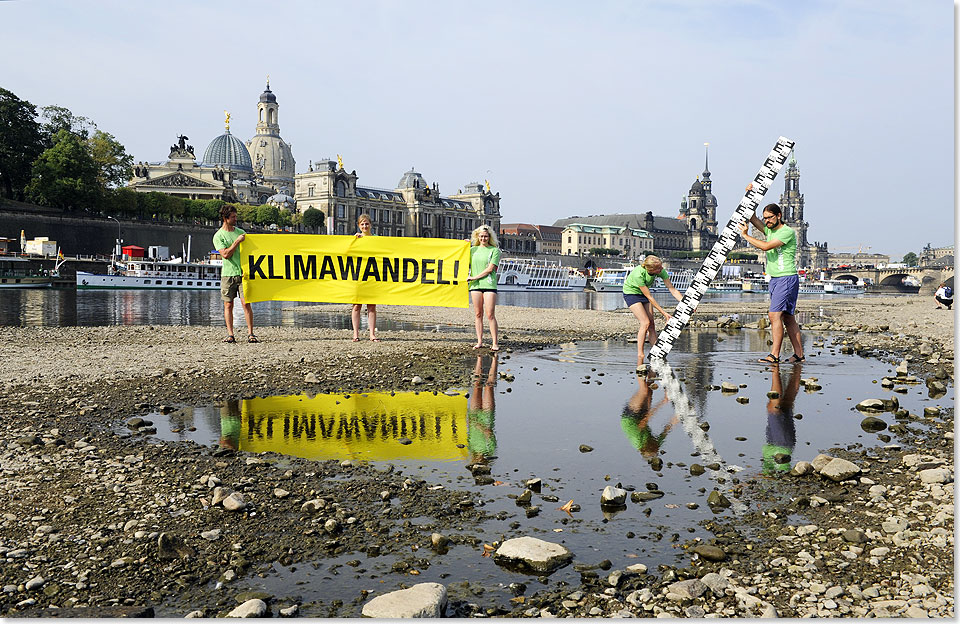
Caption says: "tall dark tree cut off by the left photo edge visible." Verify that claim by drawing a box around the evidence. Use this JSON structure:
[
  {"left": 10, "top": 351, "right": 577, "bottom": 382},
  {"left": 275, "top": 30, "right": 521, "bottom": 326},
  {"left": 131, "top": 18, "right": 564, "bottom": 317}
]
[{"left": 0, "top": 88, "right": 43, "bottom": 199}]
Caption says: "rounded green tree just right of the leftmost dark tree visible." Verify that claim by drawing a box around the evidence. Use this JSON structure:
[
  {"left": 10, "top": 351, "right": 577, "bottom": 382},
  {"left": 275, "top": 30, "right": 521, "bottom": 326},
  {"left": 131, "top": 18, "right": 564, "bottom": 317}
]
[{"left": 27, "top": 130, "right": 102, "bottom": 210}]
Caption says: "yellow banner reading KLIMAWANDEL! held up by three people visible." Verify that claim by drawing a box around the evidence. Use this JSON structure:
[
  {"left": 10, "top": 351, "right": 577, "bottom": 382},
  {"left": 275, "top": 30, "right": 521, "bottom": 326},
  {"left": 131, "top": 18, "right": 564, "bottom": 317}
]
[{"left": 238, "top": 234, "right": 470, "bottom": 308}]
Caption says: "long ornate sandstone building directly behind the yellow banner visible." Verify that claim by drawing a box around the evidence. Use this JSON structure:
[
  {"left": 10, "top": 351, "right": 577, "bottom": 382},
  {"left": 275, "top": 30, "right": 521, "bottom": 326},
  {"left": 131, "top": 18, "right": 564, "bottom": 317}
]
[{"left": 294, "top": 157, "right": 500, "bottom": 239}]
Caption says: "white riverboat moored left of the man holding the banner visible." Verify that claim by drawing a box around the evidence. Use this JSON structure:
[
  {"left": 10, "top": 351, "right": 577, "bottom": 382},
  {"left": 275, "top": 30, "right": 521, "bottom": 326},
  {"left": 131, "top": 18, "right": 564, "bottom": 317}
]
[{"left": 77, "top": 259, "right": 222, "bottom": 290}]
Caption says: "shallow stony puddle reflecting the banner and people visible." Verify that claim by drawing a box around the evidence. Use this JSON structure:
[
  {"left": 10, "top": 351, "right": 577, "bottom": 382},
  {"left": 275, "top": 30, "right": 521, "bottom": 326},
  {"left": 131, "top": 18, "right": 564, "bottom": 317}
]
[{"left": 151, "top": 331, "right": 952, "bottom": 617}]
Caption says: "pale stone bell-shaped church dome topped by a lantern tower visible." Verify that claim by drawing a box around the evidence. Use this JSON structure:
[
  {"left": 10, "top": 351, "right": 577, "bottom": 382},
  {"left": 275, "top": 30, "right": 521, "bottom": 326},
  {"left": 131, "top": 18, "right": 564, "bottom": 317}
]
[{"left": 246, "top": 78, "right": 296, "bottom": 194}]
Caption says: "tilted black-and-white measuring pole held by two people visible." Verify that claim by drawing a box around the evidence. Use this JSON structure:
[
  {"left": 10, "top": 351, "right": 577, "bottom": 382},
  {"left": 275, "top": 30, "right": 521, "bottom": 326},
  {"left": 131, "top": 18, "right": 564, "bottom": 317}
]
[{"left": 650, "top": 137, "right": 793, "bottom": 361}]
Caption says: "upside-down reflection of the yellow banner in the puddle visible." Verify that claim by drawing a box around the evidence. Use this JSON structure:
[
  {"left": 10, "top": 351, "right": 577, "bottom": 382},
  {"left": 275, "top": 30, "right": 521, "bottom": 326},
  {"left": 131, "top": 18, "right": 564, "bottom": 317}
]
[{"left": 220, "top": 392, "right": 467, "bottom": 461}]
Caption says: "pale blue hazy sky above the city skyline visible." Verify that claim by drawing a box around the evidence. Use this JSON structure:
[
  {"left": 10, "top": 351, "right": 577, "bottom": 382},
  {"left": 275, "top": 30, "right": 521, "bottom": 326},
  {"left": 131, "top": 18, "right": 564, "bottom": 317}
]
[{"left": 0, "top": 0, "right": 955, "bottom": 259}]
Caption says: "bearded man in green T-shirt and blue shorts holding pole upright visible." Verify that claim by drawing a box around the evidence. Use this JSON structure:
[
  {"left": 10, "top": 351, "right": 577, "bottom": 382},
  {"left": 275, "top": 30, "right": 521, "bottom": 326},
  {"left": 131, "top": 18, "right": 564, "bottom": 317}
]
[{"left": 740, "top": 183, "right": 804, "bottom": 364}]
